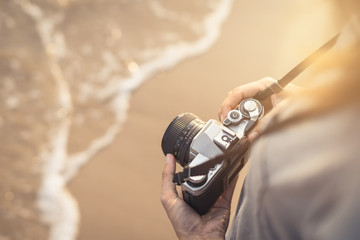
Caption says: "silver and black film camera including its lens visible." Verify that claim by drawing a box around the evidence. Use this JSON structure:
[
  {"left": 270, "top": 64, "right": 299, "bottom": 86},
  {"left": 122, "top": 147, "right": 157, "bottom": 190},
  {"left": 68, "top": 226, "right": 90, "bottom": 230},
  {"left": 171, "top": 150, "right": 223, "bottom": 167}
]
[{"left": 162, "top": 98, "right": 264, "bottom": 215}]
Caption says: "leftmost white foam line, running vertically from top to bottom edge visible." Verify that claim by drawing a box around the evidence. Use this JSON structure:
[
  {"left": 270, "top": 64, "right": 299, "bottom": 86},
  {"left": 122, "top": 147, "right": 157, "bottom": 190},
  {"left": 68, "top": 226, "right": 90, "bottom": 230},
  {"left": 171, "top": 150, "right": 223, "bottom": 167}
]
[{"left": 16, "top": 0, "right": 79, "bottom": 240}]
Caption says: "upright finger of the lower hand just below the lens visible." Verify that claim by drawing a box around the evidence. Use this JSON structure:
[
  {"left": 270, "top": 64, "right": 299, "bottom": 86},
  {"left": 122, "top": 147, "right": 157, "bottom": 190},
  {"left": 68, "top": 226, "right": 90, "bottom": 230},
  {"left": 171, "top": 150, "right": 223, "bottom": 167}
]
[{"left": 161, "top": 154, "right": 178, "bottom": 207}]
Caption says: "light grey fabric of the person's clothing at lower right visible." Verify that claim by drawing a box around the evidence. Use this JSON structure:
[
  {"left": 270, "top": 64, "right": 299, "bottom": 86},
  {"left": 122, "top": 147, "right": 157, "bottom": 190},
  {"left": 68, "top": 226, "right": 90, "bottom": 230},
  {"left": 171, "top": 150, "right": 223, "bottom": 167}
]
[{"left": 227, "top": 107, "right": 360, "bottom": 240}]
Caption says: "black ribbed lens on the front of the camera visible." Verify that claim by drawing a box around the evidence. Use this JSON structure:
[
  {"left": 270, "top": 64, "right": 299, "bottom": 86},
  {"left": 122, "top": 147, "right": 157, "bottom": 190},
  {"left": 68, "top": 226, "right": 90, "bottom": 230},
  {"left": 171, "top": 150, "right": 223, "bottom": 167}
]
[{"left": 161, "top": 113, "right": 205, "bottom": 167}]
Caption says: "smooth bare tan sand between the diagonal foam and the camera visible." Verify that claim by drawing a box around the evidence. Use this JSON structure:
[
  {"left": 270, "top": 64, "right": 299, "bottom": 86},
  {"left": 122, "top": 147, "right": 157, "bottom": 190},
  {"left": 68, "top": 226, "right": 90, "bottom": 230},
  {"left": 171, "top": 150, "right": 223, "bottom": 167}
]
[{"left": 69, "top": 1, "right": 338, "bottom": 240}]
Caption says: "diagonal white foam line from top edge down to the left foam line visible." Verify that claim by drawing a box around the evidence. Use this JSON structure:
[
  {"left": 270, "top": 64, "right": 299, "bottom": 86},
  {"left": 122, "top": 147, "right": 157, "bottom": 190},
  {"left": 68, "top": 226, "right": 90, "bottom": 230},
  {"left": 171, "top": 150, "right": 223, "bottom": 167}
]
[{"left": 64, "top": 0, "right": 233, "bottom": 181}]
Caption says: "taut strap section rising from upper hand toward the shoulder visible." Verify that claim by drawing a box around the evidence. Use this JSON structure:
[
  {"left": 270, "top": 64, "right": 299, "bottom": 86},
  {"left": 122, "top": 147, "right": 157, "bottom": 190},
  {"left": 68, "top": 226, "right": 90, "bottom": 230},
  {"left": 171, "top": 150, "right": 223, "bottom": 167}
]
[{"left": 254, "top": 34, "right": 340, "bottom": 101}]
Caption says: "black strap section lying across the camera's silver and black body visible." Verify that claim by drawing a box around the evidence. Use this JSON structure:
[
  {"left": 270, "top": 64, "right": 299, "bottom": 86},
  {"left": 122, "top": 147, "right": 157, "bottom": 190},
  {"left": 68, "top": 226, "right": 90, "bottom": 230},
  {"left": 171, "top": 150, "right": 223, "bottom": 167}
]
[{"left": 173, "top": 137, "right": 249, "bottom": 185}]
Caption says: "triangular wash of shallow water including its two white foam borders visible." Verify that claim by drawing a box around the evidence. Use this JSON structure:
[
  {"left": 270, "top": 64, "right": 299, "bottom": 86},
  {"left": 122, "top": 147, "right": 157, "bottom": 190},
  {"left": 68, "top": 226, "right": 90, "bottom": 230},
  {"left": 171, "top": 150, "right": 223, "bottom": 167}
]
[{"left": 10, "top": 0, "right": 233, "bottom": 240}]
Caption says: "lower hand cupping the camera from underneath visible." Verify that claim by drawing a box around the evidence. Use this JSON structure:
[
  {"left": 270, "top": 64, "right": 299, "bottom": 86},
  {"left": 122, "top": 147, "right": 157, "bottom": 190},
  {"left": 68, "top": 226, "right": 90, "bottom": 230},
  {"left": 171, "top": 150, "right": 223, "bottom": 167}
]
[{"left": 161, "top": 154, "right": 237, "bottom": 239}]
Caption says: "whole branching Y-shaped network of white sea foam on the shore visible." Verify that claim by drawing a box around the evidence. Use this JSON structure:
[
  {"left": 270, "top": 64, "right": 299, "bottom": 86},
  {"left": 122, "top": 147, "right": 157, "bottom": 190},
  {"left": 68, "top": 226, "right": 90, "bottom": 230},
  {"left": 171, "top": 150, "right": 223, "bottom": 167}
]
[{"left": 17, "top": 0, "right": 233, "bottom": 240}]
